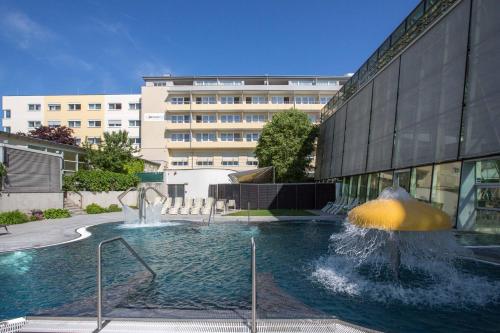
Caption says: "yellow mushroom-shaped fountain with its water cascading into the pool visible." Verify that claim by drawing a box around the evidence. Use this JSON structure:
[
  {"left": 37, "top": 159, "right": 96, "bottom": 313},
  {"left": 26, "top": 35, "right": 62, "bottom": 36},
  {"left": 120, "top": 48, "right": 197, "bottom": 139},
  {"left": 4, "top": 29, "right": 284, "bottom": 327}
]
[{"left": 313, "top": 188, "right": 500, "bottom": 306}]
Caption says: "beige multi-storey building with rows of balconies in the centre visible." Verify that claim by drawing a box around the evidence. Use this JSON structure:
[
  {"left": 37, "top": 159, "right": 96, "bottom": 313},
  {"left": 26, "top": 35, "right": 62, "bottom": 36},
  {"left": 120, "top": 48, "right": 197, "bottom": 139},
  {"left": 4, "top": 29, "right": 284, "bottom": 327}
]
[{"left": 141, "top": 76, "right": 349, "bottom": 171}]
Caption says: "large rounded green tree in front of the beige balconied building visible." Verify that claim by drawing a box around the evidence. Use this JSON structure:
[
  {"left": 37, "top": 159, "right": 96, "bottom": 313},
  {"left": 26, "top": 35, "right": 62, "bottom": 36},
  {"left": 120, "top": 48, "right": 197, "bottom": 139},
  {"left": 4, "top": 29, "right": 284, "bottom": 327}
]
[{"left": 255, "top": 108, "right": 318, "bottom": 182}]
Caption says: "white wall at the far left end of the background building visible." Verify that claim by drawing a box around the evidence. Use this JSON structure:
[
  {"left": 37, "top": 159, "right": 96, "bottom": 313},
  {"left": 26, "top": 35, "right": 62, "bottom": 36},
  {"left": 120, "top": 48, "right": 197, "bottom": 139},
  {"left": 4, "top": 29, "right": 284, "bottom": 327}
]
[{"left": 2, "top": 96, "right": 45, "bottom": 133}]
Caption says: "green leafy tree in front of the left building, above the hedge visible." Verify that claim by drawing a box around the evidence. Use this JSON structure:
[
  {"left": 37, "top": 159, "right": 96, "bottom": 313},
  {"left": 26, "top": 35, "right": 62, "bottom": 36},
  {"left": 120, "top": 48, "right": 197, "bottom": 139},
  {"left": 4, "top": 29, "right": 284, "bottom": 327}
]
[{"left": 84, "top": 131, "right": 141, "bottom": 173}]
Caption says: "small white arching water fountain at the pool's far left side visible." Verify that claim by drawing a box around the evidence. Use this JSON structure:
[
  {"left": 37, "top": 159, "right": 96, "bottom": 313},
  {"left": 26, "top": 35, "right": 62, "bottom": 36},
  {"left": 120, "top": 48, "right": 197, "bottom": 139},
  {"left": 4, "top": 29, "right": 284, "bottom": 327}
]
[{"left": 118, "top": 186, "right": 167, "bottom": 226}]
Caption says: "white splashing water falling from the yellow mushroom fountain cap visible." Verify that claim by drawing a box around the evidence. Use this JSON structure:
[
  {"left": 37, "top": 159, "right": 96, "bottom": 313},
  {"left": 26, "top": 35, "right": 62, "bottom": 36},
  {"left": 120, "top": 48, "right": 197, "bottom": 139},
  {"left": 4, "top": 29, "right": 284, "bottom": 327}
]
[{"left": 313, "top": 188, "right": 500, "bottom": 307}]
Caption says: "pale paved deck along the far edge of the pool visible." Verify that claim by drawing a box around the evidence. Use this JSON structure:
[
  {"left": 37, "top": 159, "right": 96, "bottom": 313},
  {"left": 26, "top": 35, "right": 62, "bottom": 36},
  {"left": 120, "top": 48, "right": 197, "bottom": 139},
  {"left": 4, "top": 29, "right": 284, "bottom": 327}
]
[{"left": 0, "top": 212, "right": 340, "bottom": 252}]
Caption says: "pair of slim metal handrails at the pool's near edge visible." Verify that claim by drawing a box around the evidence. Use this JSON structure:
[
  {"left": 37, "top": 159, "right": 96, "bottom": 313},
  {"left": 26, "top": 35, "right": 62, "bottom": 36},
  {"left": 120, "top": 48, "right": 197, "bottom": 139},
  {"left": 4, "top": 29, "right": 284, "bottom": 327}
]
[{"left": 97, "top": 237, "right": 257, "bottom": 333}]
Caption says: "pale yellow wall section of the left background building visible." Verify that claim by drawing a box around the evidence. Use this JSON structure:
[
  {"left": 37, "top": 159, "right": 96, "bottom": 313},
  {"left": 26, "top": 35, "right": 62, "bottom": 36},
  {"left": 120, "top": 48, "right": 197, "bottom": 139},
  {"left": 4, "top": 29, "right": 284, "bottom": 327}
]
[{"left": 42, "top": 95, "right": 106, "bottom": 142}]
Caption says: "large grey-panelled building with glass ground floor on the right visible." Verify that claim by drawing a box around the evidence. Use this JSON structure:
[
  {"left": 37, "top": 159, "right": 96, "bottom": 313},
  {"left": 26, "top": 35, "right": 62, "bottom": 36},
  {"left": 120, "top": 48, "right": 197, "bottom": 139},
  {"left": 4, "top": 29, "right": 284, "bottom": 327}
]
[{"left": 315, "top": 0, "right": 500, "bottom": 232}]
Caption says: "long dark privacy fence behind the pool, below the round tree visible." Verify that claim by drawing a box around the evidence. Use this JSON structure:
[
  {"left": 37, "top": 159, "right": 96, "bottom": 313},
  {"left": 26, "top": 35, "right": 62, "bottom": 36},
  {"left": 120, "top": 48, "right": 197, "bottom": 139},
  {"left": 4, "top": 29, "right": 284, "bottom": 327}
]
[{"left": 208, "top": 183, "right": 335, "bottom": 209}]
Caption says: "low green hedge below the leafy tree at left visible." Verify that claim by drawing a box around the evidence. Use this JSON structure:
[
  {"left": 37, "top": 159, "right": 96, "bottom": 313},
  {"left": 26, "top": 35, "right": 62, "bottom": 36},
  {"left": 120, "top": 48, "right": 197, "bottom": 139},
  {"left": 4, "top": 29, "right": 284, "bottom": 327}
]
[{"left": 63, "top": 170, "right": 139, "bottom": 192}]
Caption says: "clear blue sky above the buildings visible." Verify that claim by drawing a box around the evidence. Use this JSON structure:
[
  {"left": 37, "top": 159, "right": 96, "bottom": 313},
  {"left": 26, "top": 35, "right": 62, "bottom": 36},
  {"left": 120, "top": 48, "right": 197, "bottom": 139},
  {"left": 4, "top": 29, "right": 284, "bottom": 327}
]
[{"left": 0, "top": 0, "right": 418, "bottom": 95}]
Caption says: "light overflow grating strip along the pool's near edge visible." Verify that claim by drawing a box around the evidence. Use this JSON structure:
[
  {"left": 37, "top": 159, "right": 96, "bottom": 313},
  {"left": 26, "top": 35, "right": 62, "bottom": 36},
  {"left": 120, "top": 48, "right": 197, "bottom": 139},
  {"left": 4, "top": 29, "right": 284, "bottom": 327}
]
[{"left": 17, "top": 318, "right": 376, "bottom": 333}]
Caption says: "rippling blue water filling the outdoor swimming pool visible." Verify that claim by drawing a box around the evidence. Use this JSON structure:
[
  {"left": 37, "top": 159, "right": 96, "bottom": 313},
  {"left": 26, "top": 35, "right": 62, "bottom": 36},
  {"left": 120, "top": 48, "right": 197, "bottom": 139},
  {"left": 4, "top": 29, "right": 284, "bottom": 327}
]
[{"left": 0, "top": 222, "right": 500, "bottom": 332}]
